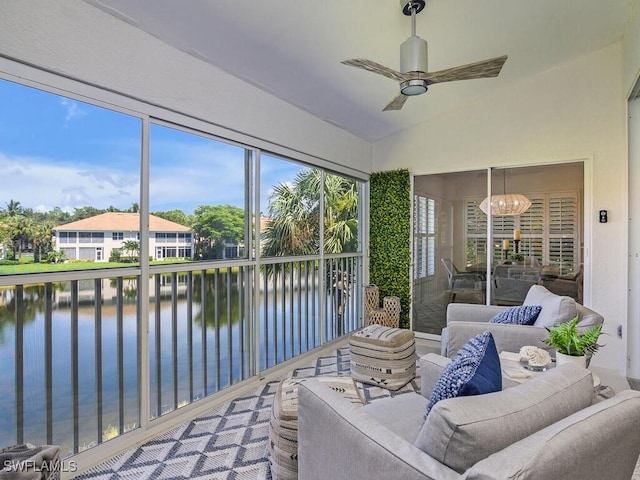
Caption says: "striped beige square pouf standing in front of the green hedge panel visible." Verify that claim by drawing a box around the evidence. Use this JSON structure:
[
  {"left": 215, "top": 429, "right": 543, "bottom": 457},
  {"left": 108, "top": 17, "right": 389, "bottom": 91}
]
[{"left": 349, "top": 325, "right": 416, "bottom": 390}]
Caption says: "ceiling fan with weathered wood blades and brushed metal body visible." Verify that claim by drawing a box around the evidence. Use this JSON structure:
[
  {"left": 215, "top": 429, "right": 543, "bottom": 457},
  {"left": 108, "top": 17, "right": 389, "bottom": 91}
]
[{"left": 341, "top": 0, "right": 507, "bottom": 111}]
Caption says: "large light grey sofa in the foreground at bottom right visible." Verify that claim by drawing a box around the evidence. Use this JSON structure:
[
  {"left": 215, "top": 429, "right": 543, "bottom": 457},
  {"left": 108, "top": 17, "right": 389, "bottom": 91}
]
[{"left": 298, "top": 354, "right": 640, "bottom": 480}]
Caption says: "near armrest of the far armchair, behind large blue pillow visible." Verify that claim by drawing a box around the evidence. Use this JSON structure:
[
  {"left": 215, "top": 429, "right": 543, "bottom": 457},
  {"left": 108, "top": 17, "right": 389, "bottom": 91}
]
[{"left": 441, "top": 322, "right": 553, "bottom": 358}]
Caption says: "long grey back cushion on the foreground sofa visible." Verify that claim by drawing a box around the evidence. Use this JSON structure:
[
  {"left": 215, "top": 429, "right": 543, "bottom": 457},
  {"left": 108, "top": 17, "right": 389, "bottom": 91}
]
[{"left": 415, "top": 365, "right": 593, "bottom": 473}]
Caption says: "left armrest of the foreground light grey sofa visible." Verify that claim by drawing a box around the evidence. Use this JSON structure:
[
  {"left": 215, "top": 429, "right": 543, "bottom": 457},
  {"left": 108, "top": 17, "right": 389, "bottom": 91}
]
[{"left": 298, "top": 381, "right": 459, "bottom": 480}]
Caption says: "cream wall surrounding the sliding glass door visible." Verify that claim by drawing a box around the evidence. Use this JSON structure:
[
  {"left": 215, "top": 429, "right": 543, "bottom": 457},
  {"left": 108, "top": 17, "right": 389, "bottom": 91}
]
[{"left": 373, "top": 43, "right": 627, "bottom": 371}]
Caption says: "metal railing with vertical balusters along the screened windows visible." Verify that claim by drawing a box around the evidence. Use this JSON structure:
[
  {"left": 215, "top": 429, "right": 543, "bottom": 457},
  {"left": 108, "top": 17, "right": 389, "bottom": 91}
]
[{"left": 0, "top": 254, "right": 362, "bottom": 456}]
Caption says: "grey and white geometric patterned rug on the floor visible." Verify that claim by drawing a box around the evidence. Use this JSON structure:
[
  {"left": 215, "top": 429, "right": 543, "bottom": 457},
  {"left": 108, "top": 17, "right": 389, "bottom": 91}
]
[{"left": 75, "top": 346, "right": 420, "bottom": 480}]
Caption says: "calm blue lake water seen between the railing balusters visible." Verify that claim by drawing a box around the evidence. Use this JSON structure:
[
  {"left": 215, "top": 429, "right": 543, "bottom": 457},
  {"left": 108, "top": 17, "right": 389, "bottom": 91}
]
[{"left": 0, "top": 273, "right": 331, "bottom": 456}]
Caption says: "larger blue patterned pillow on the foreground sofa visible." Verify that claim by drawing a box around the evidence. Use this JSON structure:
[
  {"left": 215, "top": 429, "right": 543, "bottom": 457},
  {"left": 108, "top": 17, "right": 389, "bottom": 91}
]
[{"left": 424, "top": 332, "right": 502, "bottom": 418}]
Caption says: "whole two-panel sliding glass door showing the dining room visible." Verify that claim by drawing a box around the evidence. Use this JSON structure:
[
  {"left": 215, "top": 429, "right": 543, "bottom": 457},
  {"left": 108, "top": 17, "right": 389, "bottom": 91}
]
[{"left": 412, "top": 162, "right": 584, "bottom": 335}]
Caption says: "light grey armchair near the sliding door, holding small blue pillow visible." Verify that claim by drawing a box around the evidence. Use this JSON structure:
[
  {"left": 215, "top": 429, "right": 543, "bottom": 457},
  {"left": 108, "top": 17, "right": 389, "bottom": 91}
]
[{"left": 440, "top": 285, "right": 604, "bottom": 357}]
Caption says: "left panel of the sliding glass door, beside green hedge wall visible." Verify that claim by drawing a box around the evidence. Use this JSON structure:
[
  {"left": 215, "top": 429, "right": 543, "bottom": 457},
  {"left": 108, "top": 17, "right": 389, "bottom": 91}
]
[{"left": 412, "top": 170, "right": 487, "bottom": 335}]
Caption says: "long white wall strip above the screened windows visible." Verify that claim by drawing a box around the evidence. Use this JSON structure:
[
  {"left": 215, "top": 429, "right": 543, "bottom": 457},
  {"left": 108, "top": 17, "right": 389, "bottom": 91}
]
[{"left": 0, "top": 0, "right": 371, "bottom": 173}]
